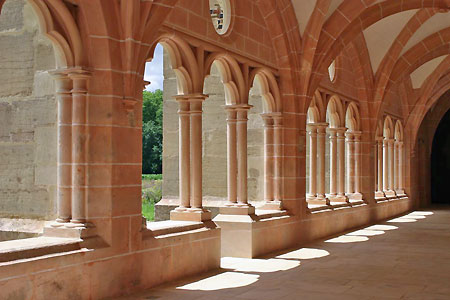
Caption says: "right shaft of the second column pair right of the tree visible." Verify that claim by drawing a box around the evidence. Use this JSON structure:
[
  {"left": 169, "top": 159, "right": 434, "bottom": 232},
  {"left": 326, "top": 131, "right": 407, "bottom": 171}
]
[{"left": 236, "top": 105, "right": 251, "bottom": 207}]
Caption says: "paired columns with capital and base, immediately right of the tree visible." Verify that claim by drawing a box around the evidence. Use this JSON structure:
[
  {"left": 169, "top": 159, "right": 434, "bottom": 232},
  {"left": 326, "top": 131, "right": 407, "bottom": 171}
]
[{"left": 170, "top": 94, "right": 211, "bottom": 221}]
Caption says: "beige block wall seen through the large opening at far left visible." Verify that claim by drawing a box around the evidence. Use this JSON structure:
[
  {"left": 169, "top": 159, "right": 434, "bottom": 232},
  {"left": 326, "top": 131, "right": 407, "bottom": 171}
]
[{"left": 0, "top": 0, "right": 57, "bottom": 219}]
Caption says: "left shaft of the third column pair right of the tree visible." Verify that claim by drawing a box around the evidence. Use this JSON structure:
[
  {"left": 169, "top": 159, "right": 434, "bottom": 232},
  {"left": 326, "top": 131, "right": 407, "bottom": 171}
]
[{"left": 261, "top": 114, "right": 274, "bottom": 202}]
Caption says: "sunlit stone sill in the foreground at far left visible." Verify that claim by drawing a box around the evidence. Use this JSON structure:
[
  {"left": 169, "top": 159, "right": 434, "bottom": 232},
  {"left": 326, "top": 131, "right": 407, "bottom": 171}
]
[{"left": 0, "top": 237, "right": 83, "bottom": 266}]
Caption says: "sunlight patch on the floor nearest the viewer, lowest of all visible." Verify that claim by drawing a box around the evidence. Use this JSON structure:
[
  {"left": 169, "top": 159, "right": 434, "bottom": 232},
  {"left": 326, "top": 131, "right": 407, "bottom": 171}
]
[{"left": 177, "top": 272, "right": 259, "bottom": 291}]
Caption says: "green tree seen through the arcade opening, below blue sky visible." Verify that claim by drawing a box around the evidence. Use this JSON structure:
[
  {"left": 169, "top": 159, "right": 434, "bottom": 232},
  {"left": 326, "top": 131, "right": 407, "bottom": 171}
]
[{"left": 142, "top": 90, "right": 163, "bottom": 174}]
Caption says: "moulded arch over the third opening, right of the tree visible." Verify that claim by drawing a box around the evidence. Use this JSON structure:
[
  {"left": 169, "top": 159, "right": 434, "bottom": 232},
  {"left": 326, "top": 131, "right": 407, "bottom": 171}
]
[{"left": 250, "top": 68, "right": 281, "bottom": 113}]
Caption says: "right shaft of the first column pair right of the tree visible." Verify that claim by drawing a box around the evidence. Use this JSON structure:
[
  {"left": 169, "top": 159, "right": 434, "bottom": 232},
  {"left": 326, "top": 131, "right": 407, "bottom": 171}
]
[{"left": 189, "top": 95, "right": 205, "bottom": 211}]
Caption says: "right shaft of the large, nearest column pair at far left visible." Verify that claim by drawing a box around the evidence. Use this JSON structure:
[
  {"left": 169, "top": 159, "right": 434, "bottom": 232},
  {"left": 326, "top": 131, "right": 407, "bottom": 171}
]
[{"left": 69, "top": 70, "right": 90, "bottom": 226}]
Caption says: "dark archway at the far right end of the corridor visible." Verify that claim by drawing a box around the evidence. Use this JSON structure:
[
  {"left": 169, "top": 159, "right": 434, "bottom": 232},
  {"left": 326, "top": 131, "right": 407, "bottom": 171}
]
[{"left": 431, "top": 110, "right": 450, "bottom": 204}]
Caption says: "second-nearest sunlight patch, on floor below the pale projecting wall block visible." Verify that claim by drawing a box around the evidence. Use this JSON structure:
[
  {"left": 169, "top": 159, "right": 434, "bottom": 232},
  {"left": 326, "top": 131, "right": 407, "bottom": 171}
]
[{"left": 221, "top": 257, "right": 300, "bottom": 273}]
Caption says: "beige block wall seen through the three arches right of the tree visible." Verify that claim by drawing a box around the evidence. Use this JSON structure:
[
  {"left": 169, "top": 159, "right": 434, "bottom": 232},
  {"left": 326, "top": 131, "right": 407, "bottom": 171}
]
[{"left": 162, "top": 51, "right": 264, "bottom": 212}]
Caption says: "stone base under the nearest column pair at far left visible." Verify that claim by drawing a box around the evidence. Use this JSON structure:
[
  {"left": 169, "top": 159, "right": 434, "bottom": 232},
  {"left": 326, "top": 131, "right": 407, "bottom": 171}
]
[{"left": 43, "top": 221, "right": 97, "bottom": 239}]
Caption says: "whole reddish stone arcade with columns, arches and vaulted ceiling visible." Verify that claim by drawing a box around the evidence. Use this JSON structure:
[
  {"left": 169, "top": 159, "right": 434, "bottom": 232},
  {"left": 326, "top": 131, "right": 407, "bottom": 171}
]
[{"left": 0, "top": 0, "right": 450, "bottom": 299}]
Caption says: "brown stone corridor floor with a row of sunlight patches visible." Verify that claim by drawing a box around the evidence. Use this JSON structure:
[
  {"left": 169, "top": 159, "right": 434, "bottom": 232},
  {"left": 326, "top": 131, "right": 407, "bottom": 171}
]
[{"left": 114, "top": 207, "right": 450, "bottom": 300}]
